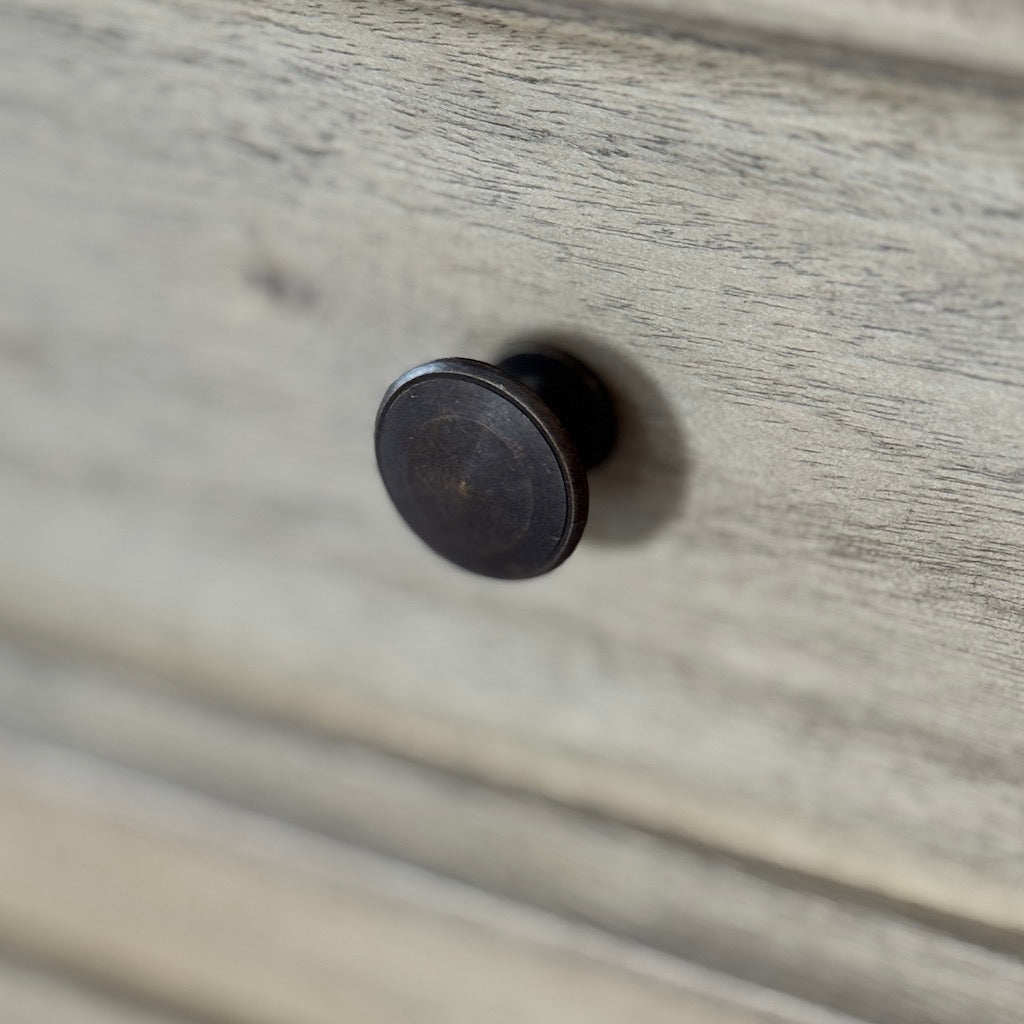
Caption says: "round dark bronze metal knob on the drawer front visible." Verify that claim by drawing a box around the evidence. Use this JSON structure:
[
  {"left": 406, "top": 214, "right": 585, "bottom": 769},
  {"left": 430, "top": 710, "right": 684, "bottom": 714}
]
[{"left": 376, "top": 349, "right": 615, "bottom": 580}]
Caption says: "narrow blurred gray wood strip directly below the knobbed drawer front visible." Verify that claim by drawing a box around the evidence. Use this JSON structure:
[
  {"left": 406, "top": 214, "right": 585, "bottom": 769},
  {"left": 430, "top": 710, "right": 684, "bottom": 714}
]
[{"left": 0, "top": 641, "right": 1024, "bottom": 1024}]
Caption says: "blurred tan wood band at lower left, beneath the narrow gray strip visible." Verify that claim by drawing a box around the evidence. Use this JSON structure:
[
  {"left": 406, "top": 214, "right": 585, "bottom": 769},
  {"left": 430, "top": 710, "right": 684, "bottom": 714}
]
[{"left": 0, "top": 737, "right": 851, "bottom": 1024}]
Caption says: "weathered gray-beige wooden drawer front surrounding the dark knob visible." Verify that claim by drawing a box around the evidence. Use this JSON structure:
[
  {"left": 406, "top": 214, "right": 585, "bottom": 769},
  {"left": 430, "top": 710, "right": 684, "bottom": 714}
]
[{"left": 0, "top": 0, "right": 1024, "bottom": 991}]
